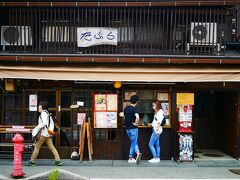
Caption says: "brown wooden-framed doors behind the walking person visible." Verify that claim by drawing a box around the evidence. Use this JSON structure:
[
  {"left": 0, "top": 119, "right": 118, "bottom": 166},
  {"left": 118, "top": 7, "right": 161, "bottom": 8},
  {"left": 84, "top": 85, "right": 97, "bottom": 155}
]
[{"left": 30, "top": 90, "right": 73, "bottom": 158}]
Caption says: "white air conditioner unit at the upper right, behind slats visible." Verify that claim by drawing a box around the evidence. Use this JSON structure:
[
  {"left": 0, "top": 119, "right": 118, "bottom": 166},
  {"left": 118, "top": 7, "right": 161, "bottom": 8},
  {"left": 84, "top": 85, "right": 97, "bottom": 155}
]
[{"left": 190, "top": 22, "right": 217, "bottom": 46}]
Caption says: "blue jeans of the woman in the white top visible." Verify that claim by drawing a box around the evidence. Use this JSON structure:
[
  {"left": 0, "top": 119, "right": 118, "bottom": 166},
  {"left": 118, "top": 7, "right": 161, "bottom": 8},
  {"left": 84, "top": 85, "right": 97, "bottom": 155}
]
[{"left": 149, "top": 130, "right": 160, "bottom": 158}]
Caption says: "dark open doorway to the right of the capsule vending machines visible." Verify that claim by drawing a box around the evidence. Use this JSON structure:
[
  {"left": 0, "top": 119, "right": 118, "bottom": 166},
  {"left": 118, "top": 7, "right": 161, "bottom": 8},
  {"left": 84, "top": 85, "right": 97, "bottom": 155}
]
[{"left": 194, "top": 91, "right": 237, "bottom": 160}]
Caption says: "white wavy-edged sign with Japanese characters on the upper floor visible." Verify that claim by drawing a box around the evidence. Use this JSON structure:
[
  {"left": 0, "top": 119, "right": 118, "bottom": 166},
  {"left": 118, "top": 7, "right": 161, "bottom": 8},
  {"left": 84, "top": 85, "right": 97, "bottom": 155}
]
[{"left": 77, "top": 27, "right": 118, "bottom": 47}]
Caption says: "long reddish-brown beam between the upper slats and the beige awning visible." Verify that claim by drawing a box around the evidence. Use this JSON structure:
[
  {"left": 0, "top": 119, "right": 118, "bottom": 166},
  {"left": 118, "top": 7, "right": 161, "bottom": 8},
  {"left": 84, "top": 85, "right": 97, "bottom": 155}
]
[{"left": 0, "top": 55, "right": 240, "bottom": 65}]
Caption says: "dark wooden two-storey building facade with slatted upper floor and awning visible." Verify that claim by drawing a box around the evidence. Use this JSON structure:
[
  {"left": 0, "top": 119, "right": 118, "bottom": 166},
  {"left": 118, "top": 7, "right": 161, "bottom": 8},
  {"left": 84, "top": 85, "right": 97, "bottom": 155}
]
[{"left": 0, "top": 0, "right": 240, "bottom": 159}]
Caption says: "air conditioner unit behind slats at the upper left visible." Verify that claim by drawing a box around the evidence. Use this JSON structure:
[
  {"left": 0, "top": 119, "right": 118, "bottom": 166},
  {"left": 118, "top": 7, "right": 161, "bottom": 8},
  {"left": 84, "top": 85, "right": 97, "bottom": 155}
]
[{"left": 1, "top": 26, "right": 32, "bottom": 46}]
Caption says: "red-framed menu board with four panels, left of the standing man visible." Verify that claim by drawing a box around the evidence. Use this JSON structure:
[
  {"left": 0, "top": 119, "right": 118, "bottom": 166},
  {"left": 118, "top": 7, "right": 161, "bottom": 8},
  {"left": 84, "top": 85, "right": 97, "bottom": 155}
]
[{"left": 94, "top": 94, "right": 118, "bottom": 128}]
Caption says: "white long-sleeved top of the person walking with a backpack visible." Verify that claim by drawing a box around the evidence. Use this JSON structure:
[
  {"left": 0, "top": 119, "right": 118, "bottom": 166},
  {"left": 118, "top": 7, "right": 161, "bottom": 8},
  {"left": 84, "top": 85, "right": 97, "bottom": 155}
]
[{"left": 36, "top": 111, "right": 51, "bottom": 137}]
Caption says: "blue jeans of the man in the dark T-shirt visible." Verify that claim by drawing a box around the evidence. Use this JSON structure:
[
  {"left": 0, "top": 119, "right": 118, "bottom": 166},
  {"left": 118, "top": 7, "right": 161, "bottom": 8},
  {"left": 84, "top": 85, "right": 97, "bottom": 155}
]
[{"left": 126, "top": 128, "right": 139, "bottom": 158}]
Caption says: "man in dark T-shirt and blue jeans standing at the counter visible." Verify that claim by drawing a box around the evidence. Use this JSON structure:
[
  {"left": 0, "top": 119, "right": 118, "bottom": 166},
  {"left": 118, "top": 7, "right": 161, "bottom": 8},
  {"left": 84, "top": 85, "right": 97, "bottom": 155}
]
[{"left": 124, "top": 95, "right": 141, "bottom": 164}]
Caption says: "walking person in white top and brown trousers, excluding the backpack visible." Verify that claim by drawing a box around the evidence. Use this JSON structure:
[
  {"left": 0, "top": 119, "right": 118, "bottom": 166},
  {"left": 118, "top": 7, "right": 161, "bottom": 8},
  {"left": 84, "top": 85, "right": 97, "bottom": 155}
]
[{"left": 25, "top": 101, "right": 63, "bottom": 166}]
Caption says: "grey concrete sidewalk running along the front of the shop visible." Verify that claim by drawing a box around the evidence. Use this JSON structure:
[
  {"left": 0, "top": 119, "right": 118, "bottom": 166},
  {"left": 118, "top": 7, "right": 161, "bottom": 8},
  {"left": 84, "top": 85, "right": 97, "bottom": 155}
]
[{"left": 0, "top": 159, "right": 240, "bottom": 179}]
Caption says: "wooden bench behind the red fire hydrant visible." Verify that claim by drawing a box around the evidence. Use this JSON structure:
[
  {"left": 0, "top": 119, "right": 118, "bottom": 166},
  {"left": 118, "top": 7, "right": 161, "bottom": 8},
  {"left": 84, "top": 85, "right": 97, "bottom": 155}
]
[{"left": 0, "top": 125, "right": 34, "bottom": 158}]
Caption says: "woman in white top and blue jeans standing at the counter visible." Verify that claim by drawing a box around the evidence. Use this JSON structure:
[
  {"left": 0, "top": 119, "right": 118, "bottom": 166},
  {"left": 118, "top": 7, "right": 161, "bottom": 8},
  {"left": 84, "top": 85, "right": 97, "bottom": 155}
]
[{"left": 148, "top": 100, "right": 164, "bottom": 163}]
